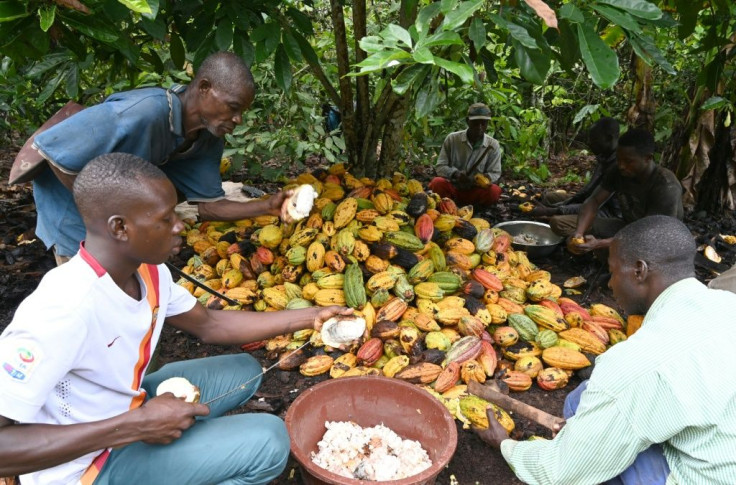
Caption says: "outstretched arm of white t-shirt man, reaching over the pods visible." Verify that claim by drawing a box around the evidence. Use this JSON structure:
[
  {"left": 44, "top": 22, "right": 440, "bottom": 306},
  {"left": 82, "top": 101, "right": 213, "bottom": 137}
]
[{"left": 166, "top": 304, "right": 353, "bottom": 345}]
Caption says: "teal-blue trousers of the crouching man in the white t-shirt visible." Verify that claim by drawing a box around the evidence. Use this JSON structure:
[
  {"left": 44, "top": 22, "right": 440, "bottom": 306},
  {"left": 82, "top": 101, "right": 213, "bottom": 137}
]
[{"left": 95, "top": 354, "right": 289, "bottom": 485}]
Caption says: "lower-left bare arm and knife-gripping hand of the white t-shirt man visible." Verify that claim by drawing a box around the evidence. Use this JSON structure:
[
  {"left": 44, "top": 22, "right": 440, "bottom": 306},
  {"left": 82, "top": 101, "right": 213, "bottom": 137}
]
[{"left": 0, "top": 394, "right": 209, "bottom": 476}]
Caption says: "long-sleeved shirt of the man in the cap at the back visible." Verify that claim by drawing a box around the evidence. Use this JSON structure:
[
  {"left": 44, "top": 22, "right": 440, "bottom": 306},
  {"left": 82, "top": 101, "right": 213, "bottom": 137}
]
[{"left": 437, "top": 130, "right": 503, "bottom": 182}]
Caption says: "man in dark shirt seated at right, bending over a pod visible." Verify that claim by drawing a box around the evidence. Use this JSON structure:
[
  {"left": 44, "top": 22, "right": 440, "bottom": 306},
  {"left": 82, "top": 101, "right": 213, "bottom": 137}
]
[{"left": 568, "top": 129, "right": 683, "bottom": 254}]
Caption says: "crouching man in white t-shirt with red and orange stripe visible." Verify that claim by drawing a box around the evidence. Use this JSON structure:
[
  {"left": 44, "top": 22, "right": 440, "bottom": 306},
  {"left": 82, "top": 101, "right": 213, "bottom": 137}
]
[{"left": 0, "top": 153, "right": 351, "bottom": 485}]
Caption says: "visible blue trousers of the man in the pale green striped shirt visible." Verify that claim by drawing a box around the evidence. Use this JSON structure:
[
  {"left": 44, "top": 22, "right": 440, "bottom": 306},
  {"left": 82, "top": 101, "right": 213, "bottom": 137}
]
[{"left": 562, "top": 380, "right": 670, "bottom": 485}]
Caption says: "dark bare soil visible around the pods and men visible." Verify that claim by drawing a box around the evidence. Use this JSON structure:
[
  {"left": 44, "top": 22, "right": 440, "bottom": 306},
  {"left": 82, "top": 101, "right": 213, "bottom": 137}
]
[{"left": 0, "top": 149, "right": 736, "bottom": 485}]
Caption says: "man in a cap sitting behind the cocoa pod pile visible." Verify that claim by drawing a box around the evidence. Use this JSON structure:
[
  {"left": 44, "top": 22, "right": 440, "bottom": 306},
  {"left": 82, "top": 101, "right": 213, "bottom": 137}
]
[{"left": 429, "top": 103, "right": 503, "bottom": 205}]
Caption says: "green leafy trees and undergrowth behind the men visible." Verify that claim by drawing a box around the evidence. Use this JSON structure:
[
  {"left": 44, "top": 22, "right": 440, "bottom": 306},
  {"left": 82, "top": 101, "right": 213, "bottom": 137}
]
[{"left": 0, "top": 0, "right": 736, "bottom": 215}]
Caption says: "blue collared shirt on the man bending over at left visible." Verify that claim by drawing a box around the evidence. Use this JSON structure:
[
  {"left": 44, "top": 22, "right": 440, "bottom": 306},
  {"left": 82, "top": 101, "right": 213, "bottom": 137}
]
[{"left": 33, "top": 85, "right": 225, "bottom": 256}]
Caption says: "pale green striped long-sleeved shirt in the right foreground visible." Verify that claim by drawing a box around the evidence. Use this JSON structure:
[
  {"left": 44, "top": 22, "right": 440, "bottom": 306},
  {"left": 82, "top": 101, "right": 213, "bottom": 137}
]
[{"left": 501, "top": 278, "right": 736, "bottom": 485}]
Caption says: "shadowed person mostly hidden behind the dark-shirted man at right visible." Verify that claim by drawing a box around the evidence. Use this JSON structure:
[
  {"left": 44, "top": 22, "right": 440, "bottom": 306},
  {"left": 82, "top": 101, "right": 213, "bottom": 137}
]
[{"left": 530, "top": 118, "right": 621, "bottom": 231}]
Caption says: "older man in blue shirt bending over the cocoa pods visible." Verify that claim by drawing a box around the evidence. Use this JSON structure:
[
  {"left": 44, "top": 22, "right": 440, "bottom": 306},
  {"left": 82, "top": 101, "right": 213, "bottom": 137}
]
[{"left": 33, "top": 52, "right": 287, "bottom": 263}]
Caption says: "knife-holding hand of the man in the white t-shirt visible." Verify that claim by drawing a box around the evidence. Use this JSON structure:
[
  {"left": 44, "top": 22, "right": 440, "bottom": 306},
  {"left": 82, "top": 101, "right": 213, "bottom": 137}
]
[{"left": 134, "top": 392, "right": 210, "bottom": 445}]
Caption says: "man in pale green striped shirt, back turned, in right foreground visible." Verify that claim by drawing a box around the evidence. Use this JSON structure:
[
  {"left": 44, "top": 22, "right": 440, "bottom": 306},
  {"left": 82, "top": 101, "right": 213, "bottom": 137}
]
[{"left": 478, "top": 215, "right": 736, "bottom": 485}]
